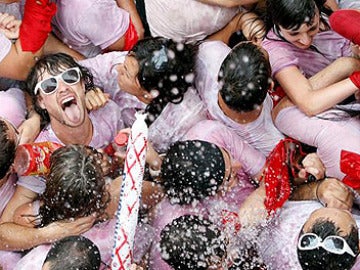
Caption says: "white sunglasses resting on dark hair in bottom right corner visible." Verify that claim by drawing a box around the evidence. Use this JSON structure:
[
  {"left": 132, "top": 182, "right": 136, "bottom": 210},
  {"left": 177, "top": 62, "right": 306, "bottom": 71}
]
[{"left": 298, "top": 233, "right": 356, "bottom": 257}]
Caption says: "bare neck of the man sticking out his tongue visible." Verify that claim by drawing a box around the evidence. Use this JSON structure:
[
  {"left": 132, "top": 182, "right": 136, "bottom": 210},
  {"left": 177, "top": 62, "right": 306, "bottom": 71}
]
[{"left": 51, "top": 116, "right": 93, "bottom": 145}]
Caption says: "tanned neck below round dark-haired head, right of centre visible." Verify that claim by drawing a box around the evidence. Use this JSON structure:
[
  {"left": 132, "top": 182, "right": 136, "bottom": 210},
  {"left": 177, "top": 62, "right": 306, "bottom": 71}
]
[{"left": 218, "top": 94, "right": 262, "bottom": 124}]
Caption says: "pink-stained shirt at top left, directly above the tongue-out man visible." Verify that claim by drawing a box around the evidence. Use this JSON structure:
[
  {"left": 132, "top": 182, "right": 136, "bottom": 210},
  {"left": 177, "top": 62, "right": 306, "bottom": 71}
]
[{"left": 52, "top": 0, "right": 130, "bottom": 57}]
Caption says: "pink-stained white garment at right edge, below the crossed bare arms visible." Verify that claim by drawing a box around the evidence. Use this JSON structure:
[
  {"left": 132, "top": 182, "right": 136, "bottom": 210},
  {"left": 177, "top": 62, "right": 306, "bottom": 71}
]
[{"left": 275, "top": 106, "right": 360, "bottom": 179}]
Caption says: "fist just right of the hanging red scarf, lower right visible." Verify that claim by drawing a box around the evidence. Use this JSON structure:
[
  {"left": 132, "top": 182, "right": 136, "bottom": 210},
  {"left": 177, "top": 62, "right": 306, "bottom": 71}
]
[{"left": 299, "top": 153, "right": 325, "bottom": 180}]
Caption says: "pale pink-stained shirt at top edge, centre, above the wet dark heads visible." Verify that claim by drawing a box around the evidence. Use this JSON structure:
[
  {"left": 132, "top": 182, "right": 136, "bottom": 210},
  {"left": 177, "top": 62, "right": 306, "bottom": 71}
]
[{"left": 144, "top": 0, "right": 239, "bottom": 42}]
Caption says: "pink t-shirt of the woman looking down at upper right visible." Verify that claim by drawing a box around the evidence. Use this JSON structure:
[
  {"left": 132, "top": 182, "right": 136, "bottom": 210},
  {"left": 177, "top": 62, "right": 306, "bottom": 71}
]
[{"left": 262, "top": 28, "right": 352, "bottom": 78}]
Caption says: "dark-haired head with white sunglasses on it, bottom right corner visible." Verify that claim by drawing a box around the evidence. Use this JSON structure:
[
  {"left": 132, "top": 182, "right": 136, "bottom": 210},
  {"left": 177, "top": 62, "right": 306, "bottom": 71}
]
[{"left": 297, "top": 209, "right": 359, "bottom": 270}]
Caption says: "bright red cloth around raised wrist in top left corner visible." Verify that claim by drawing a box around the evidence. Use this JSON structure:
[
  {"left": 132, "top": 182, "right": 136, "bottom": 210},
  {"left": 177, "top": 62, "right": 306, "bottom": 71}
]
[{"left": 20, "top": 0, "right": 56, "bottom": 53}]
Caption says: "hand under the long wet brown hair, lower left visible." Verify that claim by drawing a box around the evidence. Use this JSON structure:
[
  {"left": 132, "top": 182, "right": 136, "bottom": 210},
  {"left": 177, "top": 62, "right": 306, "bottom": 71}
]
[{"left": 42, "top": 215, "right": 96, "bottom": 242}]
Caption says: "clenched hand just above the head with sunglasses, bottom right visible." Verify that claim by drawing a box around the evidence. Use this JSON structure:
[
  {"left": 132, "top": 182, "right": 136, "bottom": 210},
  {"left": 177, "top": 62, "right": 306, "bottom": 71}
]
[{"left": 316, "top": 178, "right": 354, "bottom": 210}]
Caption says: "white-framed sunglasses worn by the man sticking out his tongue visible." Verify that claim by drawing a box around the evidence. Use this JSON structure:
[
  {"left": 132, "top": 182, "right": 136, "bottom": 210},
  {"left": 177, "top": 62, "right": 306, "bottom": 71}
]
[{"left": 34, "top": 67, "right": 81, "bottom": 95}]
